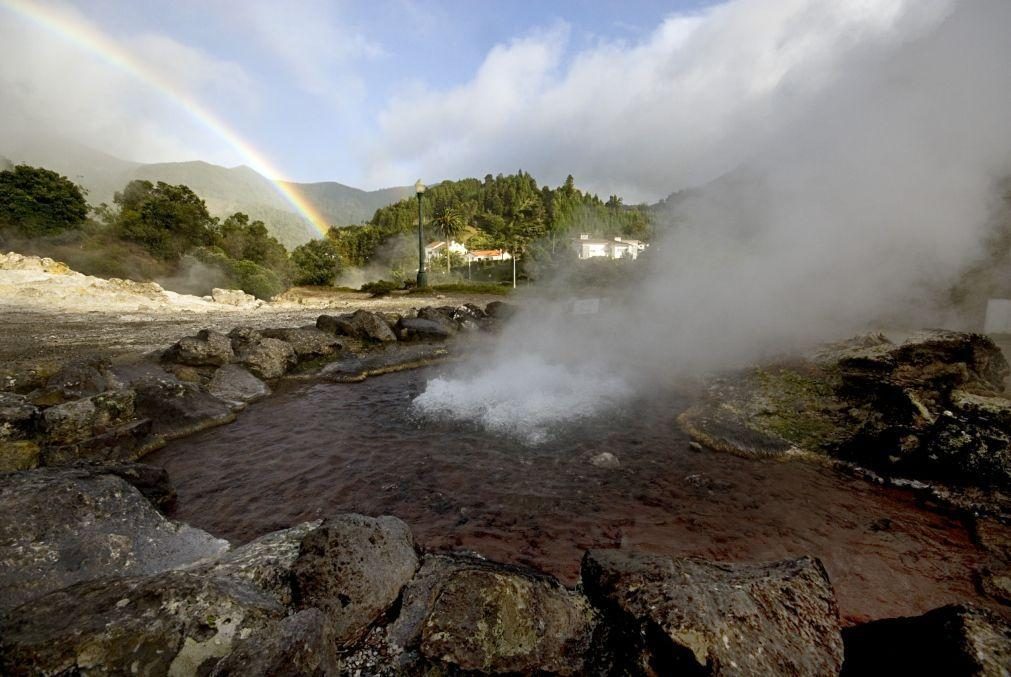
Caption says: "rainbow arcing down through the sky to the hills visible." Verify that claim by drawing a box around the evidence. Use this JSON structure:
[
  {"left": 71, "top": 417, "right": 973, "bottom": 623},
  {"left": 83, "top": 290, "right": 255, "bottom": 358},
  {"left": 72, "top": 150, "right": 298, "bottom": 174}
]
[{"left": 0, "top": 0, "right": 328, "bottom": 235}]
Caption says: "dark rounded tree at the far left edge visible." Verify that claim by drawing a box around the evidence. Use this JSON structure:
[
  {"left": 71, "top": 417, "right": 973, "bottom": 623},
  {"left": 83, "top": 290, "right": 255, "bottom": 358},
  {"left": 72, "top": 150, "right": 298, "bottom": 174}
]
[{"left": 0, "top": 165, "right": 88, "bottom": 237}]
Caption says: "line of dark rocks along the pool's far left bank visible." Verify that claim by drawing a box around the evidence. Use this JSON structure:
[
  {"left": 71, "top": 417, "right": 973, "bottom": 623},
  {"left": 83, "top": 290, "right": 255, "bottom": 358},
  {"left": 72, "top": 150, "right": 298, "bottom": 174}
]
[{"left": 0, "top": 305, "right": 517, "bottom": 473}]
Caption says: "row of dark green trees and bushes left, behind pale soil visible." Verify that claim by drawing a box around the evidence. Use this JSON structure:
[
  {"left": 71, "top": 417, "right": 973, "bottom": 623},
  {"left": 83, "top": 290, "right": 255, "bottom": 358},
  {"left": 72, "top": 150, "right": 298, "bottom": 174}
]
[{"left": 0, "top": 165, "right": 341, "bottom": 298}]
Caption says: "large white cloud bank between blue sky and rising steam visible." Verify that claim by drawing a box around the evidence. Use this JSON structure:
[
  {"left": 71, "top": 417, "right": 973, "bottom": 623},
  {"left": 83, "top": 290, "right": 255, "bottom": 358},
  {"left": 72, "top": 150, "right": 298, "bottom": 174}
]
[{"left": 364, "top": 0, "right": 951, "bottom": 199}]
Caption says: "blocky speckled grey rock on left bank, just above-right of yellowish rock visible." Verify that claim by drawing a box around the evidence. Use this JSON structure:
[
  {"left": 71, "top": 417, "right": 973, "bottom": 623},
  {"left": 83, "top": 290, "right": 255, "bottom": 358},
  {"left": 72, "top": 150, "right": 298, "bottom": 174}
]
[{"left": 41, "top": 390, "right": 134, "bottom": 446}]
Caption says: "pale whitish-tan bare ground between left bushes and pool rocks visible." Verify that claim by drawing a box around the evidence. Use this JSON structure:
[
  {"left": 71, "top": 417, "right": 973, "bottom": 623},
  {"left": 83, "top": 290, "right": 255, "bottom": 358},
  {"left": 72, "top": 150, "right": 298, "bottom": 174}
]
[{"left": 0, "top": 262, "right": 503, "bottom": 372}]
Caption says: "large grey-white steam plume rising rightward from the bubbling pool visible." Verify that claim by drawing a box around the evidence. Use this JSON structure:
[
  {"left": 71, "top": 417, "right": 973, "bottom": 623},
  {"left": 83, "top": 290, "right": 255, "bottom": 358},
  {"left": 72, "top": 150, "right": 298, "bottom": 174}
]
[{"left": 416, "top": 0, "right": 1011, "bottom": 440}]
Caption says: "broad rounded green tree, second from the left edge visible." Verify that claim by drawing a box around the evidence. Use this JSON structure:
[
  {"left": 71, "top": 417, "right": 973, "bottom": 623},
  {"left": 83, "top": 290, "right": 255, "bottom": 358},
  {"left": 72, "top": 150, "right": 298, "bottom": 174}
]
[{"left": 111, "top": 181, "right": 214, "bottom": 261}]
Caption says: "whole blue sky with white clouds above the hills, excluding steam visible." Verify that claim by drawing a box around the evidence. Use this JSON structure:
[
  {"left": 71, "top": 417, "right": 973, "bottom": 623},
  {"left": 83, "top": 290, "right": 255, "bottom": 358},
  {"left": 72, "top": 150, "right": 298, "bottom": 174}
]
[{"left": 0, "top": 0, "right": 951, "bottom": 199}]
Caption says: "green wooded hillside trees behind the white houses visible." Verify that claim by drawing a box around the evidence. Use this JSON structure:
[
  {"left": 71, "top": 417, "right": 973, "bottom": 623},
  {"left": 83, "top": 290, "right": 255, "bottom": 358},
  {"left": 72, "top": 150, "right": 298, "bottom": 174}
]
[{"left": 329, "top": 171, "right": 650, "bottom": 267}]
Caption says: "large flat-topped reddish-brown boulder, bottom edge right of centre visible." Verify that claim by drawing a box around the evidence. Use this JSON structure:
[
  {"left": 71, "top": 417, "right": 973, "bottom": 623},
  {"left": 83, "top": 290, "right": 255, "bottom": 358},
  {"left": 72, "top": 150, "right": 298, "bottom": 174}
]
[{"left": 582, "top": 550, "right": 843, "bottom": 675}]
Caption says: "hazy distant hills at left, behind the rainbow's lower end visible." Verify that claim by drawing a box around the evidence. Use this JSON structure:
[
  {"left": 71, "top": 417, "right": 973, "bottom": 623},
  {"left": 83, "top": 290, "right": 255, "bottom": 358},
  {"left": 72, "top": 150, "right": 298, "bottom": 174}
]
[{"left": 0, "top": 136, "right": 412, "bottom": 250}]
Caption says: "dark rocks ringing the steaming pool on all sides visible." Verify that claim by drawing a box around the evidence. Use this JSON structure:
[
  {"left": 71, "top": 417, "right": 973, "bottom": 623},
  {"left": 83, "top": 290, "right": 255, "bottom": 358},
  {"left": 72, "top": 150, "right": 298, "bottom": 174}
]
[{"left": 0, "top": 317, "right": 1011, "bottom": 675}]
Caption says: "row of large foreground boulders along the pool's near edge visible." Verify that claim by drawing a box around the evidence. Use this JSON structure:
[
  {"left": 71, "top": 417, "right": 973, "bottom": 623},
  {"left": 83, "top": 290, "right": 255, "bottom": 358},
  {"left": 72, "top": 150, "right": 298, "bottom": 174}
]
[{"left": 0, "top": 467, "right": 1011, "bottom": 675}]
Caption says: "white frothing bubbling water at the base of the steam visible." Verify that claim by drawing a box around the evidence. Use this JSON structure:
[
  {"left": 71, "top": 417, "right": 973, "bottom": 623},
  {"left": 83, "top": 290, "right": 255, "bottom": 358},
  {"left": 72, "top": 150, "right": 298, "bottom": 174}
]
[{"left": 413, "top": 355, "right": 633, "bottom": 445}]
